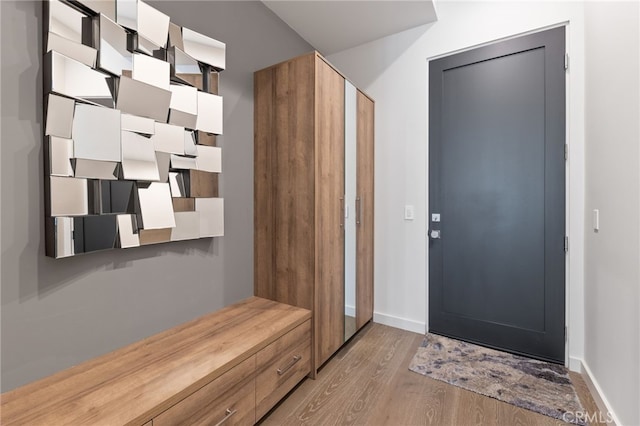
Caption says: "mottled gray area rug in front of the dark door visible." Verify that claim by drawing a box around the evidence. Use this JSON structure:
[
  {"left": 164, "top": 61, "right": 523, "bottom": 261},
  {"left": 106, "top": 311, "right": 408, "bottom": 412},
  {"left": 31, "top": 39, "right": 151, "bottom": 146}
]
[{"left": 409, "top": 333, "right": 584, "bottom": 424}]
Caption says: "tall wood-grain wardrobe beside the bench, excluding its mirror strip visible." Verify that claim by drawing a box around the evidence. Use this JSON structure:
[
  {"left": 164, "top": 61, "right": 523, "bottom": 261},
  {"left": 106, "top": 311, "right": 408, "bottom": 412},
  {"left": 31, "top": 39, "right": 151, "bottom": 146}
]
[{"left": 254, "top": 52, "right": 373, "bottom": 376}]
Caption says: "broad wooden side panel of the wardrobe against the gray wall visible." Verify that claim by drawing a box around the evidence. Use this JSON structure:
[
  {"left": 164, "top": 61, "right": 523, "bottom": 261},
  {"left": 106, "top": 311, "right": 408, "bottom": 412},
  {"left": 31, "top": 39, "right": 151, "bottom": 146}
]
[{"left": 254, "top": 55, "right": 315, "bottom": 309}]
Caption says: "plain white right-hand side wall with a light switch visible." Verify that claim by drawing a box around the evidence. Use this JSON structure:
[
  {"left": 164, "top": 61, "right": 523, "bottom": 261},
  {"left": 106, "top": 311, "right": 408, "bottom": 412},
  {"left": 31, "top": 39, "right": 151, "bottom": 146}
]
[{"left": 584, "top": 2, "right": 640, "bottom": 425}]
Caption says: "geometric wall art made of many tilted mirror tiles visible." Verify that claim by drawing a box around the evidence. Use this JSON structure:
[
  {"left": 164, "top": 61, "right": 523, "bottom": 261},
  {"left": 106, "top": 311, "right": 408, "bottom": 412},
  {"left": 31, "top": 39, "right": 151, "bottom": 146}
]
[{"left": 43, "top": 0, "right": 225, "bottom": 258}]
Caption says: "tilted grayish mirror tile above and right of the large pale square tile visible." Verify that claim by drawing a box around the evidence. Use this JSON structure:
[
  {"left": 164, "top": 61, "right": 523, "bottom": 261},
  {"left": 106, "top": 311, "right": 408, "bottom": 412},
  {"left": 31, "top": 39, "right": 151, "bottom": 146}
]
[{"left": 116, "top": 76, "right": 171, "bottom": 123}]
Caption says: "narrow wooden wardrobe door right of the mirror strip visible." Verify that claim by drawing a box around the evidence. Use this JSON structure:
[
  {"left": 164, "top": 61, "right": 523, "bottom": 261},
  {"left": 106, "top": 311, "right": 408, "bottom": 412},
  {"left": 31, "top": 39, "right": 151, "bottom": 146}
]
[{"left": 356, "top": 91, "right": 375, "bottom": 329}]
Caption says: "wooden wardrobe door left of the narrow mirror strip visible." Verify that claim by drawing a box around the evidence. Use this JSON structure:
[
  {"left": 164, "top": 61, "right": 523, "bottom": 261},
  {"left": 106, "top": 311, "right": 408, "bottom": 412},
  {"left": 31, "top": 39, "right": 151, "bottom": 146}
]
[{"left": 313, "top": 57, "right": 345, "bottom": 368}]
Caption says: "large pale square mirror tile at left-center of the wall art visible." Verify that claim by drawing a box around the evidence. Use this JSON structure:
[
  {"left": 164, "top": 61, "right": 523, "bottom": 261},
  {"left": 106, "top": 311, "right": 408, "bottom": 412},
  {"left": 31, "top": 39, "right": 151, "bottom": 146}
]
[{"left": 72, "top": 104, "right": 122, "bottom": 161}]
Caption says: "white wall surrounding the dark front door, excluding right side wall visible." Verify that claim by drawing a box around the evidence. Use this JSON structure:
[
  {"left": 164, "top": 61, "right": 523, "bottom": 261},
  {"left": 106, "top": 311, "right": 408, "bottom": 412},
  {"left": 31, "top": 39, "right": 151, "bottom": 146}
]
[{"left": 329, "top": 2, "right": 584, "bottom": 369}]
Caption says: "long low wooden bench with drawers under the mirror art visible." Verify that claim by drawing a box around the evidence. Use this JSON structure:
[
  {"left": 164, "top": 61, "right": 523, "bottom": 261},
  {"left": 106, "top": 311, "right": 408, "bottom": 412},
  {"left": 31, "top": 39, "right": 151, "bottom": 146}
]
[{"left": 0, "top": 297, "right": 311, "bottom": 426}]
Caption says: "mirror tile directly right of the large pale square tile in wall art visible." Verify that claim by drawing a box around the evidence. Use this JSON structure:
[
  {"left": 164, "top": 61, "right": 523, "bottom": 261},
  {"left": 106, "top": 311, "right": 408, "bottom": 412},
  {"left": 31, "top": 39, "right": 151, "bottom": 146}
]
[{"left": 122, "top": 132, "right": 160, "bottom": 181}]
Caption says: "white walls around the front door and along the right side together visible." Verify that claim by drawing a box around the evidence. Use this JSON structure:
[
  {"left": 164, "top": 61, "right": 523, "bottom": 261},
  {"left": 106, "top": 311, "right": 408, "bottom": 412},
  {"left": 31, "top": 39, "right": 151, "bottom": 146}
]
[{"left": 329, "top": 1, "right": 640, "bottom": 425}]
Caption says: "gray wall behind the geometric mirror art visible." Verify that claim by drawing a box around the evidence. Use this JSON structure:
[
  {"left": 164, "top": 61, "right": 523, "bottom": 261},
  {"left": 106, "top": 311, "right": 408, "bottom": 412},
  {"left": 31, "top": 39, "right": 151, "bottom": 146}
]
[{"left": 0, "top": 1, "right": 312, "bottom": 391}]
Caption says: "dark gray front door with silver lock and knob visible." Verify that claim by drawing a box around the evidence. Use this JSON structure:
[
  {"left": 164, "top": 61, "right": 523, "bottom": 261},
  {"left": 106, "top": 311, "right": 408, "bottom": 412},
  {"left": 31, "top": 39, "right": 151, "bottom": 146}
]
[{"left": 429, "top": 28, "right": 565, "bottom": 363}]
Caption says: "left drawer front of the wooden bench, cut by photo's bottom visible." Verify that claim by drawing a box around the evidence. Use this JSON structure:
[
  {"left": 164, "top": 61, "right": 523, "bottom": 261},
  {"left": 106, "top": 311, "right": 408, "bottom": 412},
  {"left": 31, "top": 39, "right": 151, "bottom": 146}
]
[{"left": 153, "top": 355, "right": 256, "bottom": 426}]
